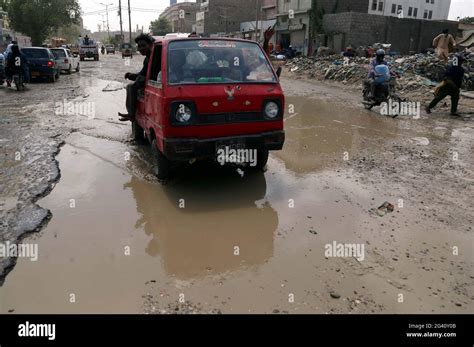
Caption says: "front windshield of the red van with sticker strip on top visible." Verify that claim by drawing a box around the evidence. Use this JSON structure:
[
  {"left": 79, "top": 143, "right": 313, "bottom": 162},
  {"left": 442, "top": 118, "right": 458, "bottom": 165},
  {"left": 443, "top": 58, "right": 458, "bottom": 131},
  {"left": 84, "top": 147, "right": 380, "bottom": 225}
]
[{"left": 168, "top": 39, "right": 276, "bottom": 85}]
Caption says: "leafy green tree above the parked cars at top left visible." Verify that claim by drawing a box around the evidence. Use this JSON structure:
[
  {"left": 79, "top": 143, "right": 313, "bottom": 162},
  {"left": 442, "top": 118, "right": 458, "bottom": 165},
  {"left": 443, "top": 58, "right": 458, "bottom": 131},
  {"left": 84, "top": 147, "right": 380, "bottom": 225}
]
[{"left": 8, "top": 0, "right": 80, "bottom": 46}]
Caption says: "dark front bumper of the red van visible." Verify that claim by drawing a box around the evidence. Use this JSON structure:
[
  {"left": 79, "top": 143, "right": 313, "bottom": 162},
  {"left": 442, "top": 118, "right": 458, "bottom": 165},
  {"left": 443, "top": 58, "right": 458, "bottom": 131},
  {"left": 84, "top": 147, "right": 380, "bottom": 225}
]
[{"left": 163, "top": 130, "right": 285, "bottom": 161}]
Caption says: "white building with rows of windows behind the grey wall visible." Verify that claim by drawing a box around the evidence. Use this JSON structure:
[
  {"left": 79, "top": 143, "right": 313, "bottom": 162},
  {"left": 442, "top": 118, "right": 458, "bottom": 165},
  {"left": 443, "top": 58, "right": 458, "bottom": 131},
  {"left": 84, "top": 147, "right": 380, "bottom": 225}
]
[{"left": 368, "top": 0, "right": 451, "bottom": 20}]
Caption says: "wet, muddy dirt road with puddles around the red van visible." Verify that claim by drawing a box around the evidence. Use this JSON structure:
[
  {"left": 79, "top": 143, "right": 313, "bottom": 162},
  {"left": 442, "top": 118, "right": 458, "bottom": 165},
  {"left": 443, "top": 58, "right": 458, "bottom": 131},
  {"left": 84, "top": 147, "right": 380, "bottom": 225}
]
[{"left": 0, "top": 56, "right": 474, "bottom": 313}]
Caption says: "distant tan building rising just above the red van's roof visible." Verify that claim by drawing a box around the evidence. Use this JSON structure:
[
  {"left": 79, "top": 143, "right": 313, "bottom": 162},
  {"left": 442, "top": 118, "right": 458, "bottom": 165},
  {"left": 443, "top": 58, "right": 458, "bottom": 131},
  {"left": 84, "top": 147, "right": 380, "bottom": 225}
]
[{"left": 160, "top": 2, "right": 199, "bottom": 33}]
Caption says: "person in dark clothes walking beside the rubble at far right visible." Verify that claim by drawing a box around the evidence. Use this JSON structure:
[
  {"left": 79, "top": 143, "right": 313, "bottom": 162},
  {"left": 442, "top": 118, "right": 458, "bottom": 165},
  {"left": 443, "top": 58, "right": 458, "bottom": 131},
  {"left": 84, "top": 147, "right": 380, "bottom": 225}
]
[{"left": 426, "top": 54, "right": 464, "bottom": 116}]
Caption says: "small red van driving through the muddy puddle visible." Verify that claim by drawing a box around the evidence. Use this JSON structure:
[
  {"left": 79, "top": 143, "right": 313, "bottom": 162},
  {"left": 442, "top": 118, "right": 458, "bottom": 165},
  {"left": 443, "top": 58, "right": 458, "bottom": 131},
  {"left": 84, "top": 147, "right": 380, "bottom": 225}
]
[{"left": 132, "top": 38, "right": 285, "bottom": 179}]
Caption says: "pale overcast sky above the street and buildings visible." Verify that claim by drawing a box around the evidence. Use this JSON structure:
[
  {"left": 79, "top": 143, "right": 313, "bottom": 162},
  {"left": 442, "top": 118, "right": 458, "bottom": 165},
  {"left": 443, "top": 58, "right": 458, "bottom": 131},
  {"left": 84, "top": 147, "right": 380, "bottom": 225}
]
[{"left": 79, "top": 0, "right": 474, "bottom": 31}]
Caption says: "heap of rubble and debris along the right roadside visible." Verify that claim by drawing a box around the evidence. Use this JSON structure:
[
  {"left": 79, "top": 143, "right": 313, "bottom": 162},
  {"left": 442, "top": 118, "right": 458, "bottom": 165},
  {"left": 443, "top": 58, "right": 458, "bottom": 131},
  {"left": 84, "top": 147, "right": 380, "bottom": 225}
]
[{"left": 286, "top": 53, "right": 474, "bottom": 91}]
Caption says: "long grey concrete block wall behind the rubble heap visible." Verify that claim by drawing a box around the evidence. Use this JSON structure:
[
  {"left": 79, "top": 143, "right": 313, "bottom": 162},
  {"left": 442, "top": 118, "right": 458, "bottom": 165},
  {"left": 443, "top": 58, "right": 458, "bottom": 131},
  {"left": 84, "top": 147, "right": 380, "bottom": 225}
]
[{"left": 323, "top": 12, "right": 458, "bottom": 54}]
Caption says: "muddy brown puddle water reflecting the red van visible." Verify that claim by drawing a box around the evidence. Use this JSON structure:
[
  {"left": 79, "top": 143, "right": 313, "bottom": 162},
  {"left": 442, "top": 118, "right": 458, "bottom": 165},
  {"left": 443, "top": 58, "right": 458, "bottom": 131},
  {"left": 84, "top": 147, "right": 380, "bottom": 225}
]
[{"left": 0, "top": 71, "right": 466, "bottom": 313}]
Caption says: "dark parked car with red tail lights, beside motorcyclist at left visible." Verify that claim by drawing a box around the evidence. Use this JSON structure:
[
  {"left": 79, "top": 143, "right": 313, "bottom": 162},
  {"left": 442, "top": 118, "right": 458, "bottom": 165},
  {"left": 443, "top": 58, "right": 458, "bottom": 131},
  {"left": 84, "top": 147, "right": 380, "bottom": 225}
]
[{"left": 21, "top": 47, "right": 59, "bottom": 83}]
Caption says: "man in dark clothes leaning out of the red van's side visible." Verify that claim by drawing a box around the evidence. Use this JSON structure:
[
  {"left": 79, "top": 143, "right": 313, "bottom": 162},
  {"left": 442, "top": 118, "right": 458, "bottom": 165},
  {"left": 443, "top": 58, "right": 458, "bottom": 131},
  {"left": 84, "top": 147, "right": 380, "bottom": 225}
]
[{"left": 119, "top": 34, "right": 155, "bottom": 122}]
